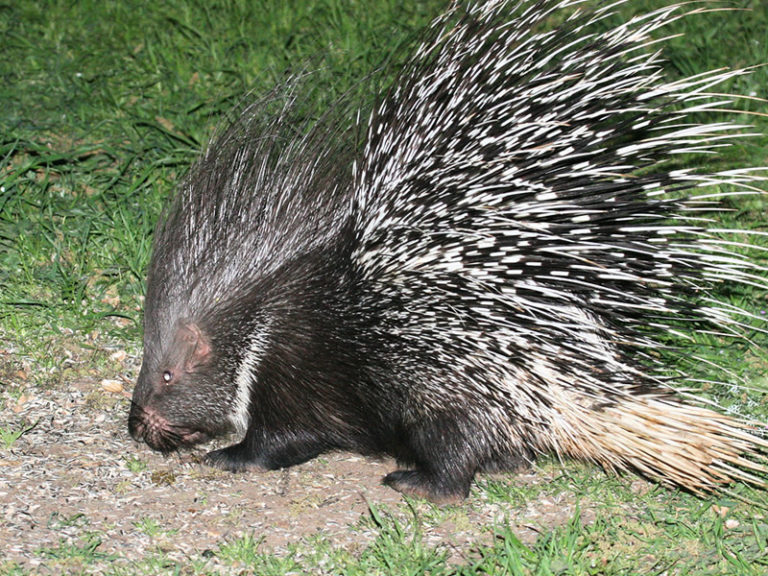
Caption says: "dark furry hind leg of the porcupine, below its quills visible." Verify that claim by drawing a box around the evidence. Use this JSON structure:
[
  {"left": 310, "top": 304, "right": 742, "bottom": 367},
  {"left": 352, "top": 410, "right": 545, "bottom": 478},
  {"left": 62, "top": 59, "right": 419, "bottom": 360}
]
[{"left": 384, "top": 414, "right": 481, "bottom": 503}]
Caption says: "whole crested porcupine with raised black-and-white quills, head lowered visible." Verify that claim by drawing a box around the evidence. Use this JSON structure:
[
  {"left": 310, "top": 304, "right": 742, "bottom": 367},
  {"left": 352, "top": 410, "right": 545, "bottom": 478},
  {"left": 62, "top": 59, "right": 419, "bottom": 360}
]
[{"left": 129, "top": 0, "right": 768, "bottom": 501}]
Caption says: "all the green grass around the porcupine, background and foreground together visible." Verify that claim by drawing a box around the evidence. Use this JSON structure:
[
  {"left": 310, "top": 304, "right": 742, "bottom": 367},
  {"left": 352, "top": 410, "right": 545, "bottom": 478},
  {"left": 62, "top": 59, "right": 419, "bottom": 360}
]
[{"left": 0, "top": 0, "right": 768, "bottom": 575}]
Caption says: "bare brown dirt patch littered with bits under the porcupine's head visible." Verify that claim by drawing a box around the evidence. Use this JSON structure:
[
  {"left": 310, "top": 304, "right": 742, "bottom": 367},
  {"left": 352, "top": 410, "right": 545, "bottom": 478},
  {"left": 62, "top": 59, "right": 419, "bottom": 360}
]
[{"left": 0, "top": 344, "right": 589, "bottom": 573}]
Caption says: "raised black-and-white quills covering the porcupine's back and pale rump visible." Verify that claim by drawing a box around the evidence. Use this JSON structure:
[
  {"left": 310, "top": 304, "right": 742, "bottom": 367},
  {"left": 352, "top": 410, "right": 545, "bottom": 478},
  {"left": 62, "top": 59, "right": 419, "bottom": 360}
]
[{"left": 354, "top": 0, "right": 766, "bottom": 492}]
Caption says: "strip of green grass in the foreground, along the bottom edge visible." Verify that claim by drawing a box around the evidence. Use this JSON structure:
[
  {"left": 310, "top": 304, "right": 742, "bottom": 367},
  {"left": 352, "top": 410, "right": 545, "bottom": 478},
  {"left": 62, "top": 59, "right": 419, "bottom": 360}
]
[{"left": 10, "top": 490, "right": 768, "bottom": 576}]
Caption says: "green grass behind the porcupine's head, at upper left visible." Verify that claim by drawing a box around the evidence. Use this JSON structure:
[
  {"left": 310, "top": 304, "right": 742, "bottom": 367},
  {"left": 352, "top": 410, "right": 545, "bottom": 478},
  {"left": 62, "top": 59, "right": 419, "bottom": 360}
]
[{"left": 0, "top": 0, "right": 448, "bottom": 342}]
